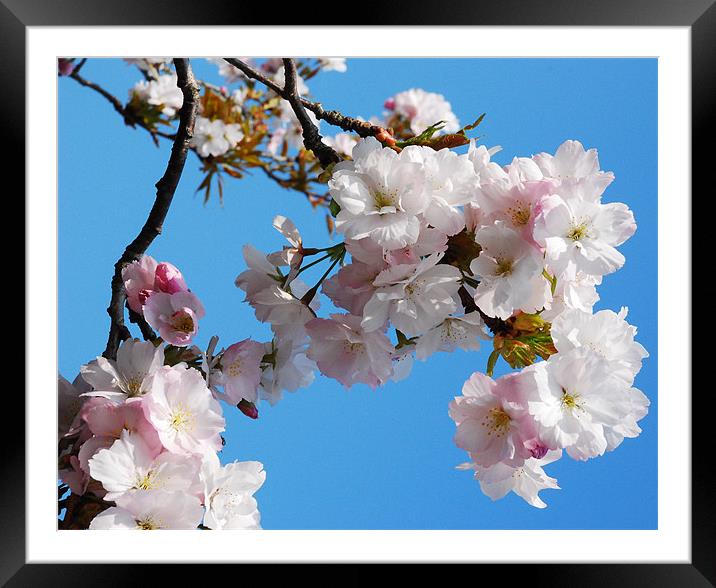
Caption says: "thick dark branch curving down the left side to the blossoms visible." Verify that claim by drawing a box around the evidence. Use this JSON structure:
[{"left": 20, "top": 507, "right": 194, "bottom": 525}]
[{"left": 102, "top": 58, "right": 199, "bottom": 359}]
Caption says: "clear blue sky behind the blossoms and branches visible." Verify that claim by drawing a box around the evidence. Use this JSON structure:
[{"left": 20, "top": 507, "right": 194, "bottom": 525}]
[{"left": 58, "top": 59, "right": 658, "bottom": 529}]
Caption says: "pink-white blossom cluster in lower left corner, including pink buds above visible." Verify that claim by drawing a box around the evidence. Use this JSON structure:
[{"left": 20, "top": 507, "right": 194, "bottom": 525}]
[{"left": 58, "top": 256, "right": 266, "bottom": 530}]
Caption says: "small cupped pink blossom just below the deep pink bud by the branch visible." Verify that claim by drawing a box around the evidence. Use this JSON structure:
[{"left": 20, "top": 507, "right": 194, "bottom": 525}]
[{"left": 144, "top": 291, "right": 204, "bottom": 347}]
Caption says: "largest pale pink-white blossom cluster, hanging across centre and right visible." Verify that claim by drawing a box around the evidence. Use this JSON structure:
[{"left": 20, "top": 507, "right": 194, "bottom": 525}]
[{"left": 236, "top": 138, "right": 649, "bottom": 507}]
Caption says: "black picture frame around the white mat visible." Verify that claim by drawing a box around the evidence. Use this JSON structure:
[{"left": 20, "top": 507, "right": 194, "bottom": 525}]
[{"left": 7, "top": 0, "right": 716, "bottom": 587}]
